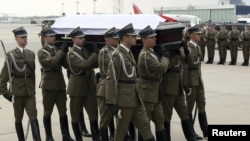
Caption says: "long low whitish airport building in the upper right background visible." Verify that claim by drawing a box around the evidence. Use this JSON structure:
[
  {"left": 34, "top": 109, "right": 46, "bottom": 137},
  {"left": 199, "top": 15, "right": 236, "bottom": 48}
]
[{"left": 153, "top": 0, "right": 250, "bottom": 23}]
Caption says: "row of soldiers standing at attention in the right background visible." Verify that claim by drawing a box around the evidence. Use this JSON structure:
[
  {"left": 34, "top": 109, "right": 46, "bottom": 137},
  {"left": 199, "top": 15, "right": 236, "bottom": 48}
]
[{"left": 183, "top": 24, "right": 250, "bottom": 66}]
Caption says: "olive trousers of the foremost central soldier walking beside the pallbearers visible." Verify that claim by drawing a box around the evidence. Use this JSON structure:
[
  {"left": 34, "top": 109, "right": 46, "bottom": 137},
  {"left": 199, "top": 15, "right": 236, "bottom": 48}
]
[{"left": 115, "top": 104, "right": 153, "bottom": 141}]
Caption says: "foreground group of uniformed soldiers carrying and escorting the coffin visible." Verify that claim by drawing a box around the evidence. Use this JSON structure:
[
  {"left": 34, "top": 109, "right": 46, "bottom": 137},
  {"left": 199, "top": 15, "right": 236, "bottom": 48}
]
[{"left": 0, "top": 23, "right": 208, "bottom": 141}]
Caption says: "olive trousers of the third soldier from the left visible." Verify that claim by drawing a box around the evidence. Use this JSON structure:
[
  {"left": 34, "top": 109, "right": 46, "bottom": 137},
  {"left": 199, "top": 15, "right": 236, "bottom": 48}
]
[{"left": 70, "top": 96, "right": 98, "bottom": 123}]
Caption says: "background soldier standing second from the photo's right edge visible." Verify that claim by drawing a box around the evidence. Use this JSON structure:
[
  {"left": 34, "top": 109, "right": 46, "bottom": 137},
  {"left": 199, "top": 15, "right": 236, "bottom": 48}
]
[{"left": 228, "top": 24, "right": 241, "bottom": 65}]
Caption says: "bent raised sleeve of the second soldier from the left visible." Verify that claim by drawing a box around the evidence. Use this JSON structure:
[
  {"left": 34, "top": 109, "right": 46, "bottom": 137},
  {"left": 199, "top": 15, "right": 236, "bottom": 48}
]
[{"left": 38, "top": 49, "right": 64, "bottom": 67}]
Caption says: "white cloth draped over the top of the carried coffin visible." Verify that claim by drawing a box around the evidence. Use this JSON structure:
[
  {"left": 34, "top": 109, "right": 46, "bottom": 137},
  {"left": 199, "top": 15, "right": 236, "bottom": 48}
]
[{"left": 51, "top": 14, "right": 166, "bottom": 35}]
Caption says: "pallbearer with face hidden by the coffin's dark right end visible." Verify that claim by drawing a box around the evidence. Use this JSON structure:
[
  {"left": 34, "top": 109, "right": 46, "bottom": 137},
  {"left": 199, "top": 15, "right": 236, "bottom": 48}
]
[{"left": 160, "top": 30, "right": 200, "bottom": 141}]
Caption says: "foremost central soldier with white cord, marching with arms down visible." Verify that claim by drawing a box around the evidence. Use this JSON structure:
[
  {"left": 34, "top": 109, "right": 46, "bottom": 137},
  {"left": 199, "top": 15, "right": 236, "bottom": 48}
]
[{"left": 106, "top": 23, "right": 155, "bottom": 141}]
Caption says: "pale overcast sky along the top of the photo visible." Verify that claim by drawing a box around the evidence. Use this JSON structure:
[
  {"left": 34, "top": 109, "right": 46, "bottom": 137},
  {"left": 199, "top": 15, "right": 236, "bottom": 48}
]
[{"left": 0, "top": 0, "right": 250, "bottom": 16}]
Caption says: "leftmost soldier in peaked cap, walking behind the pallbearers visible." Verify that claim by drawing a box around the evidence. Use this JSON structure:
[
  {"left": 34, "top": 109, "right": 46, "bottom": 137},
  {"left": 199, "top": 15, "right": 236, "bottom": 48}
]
[{"left": 0, "top": 27, "right": 41, "bottom": 141}]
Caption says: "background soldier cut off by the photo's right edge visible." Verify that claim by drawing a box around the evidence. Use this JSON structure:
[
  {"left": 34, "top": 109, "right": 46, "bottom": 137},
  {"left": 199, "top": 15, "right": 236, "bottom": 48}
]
[{"left": 241, "top": 24, "right": 250, "bottom": 66}]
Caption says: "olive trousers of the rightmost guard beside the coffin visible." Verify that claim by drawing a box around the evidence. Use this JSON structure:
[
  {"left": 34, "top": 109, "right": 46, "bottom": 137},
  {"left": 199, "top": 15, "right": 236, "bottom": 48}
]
[{"left": 187, "top": 85, "right": 206, "bottom": 113}]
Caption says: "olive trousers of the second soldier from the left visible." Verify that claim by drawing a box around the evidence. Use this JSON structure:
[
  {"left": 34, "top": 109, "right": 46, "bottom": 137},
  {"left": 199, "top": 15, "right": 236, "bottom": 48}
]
[{"left": 42, "top": 90, "right": 67, "bottom": 117}]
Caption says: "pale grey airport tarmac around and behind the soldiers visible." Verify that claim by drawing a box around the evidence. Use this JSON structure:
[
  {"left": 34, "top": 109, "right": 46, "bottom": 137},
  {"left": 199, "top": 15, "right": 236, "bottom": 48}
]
[{"left": 0, "top": 24, "right": 250, "bottom": 141}]
